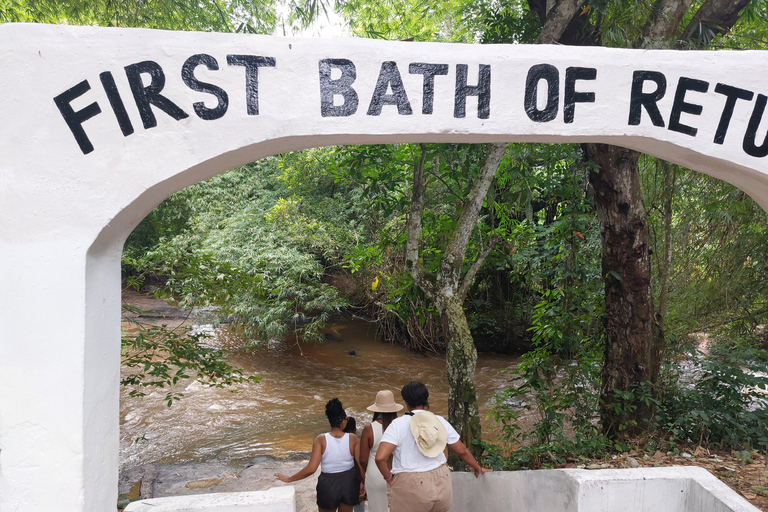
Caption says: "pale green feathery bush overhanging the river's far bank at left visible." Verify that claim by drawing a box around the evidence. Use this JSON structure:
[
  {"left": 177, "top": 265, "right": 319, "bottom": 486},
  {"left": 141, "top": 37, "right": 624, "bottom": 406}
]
[{"left": 127, "top": 159, "right": 364, "bottom": 341}]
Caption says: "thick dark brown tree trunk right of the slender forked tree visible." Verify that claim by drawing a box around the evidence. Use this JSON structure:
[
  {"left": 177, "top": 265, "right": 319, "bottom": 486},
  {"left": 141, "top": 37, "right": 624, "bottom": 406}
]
[{"left": 585, "top": 144, "right": 658, "bottom": 435}]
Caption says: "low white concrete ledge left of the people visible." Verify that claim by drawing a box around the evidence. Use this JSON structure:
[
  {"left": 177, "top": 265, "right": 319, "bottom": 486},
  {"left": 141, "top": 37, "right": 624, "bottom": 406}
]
[{"left": 125, "top": 486, "right": 296, "bottom": 512}]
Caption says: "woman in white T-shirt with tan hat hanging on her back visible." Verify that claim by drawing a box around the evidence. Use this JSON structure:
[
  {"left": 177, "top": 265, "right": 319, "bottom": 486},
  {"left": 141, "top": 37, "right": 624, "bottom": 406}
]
[{"left": 376, "top": 381, "right": 490, "bottom": 512}]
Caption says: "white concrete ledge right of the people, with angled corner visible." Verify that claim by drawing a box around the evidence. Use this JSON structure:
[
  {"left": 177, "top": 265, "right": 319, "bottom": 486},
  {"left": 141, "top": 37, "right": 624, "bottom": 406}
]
[{"left": 450, "top": 466, "right": 759, "bottom": 512}]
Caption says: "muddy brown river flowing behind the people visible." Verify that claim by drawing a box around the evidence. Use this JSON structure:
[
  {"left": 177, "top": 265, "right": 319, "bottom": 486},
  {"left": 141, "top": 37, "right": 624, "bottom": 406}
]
[{"left": 120, "top": 292, "right": 516, "bottom": 468}]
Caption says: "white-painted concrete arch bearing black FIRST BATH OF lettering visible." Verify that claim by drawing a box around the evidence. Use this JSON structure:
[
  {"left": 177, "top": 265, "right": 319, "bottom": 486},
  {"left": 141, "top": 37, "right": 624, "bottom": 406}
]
[{"left": 0, "top": 24, "right": 768, "bottom": 512}]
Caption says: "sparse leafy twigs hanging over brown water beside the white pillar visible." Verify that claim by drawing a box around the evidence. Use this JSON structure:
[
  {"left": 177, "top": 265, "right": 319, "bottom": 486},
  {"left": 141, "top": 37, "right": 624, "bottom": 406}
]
[{"left": 120, "top": 304, "right": 261, "bottom": 407}]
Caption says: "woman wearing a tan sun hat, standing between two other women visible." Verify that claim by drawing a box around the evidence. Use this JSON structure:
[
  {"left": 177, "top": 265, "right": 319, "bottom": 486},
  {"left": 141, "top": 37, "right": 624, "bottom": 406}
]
[{"left": 360, "top": 389, "right": 403, "bottom": 512}]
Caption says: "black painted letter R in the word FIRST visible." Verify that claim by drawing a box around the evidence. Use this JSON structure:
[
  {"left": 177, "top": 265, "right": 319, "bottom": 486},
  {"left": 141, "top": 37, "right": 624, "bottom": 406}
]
[{"left": 125, "top": 60, "right": 189, "bottom": 128}]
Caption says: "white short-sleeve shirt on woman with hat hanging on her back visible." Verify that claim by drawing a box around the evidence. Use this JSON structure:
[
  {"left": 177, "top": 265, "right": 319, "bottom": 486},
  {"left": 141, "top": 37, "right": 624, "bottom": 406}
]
[{"left": 381, "top": 409, "right": 460, "bottom": 473}]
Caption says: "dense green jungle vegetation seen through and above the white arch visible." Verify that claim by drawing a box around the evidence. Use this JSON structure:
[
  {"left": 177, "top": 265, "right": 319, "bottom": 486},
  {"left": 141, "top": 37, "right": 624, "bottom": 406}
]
[{"left": 9, "top": 0, "right": 768, "bottom": 468}]
